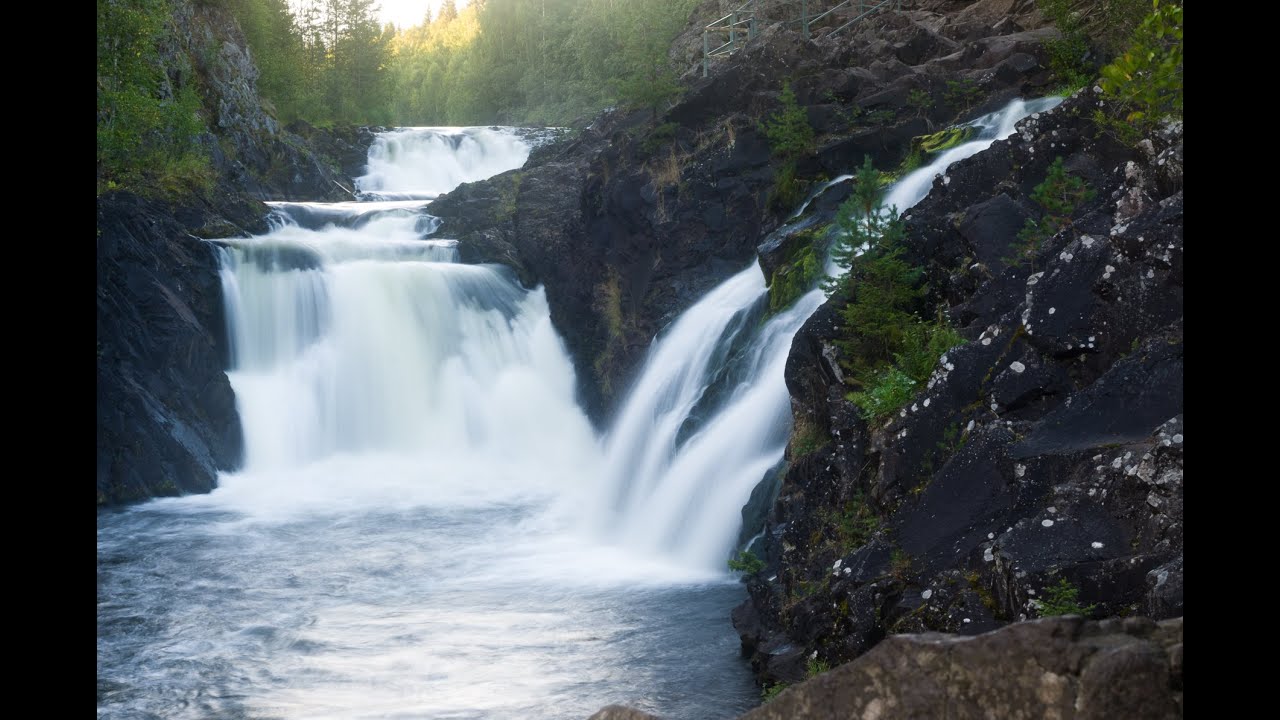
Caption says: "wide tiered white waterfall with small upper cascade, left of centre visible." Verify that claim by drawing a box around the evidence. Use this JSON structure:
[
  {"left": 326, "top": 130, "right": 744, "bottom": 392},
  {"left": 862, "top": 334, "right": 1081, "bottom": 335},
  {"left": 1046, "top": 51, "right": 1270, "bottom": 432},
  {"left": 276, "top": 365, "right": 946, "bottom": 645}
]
[{"left": 220, "top": 128, "right": 598, "bottom": 511}]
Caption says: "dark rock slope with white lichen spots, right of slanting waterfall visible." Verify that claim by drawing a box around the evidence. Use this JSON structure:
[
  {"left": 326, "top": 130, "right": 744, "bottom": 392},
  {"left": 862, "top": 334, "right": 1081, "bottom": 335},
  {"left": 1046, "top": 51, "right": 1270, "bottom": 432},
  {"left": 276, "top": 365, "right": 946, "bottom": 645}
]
[{"left": 735, "top": 90, "right": 1184, "bottom": 683}]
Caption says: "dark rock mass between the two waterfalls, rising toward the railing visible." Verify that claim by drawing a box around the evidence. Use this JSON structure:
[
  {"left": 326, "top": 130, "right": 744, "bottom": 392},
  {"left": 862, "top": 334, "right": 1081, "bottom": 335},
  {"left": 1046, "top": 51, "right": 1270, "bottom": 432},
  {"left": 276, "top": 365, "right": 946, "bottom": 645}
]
[{"left": 429, "top": 3, "right": 1053, "bottom": 425}]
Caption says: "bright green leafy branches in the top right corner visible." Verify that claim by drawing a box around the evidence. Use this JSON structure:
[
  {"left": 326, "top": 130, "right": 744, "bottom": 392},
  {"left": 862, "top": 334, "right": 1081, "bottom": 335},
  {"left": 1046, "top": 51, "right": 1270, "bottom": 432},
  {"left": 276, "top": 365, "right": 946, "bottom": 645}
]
[{"left": 1094, "top": 0, "right": 1183, "bottom": 143}]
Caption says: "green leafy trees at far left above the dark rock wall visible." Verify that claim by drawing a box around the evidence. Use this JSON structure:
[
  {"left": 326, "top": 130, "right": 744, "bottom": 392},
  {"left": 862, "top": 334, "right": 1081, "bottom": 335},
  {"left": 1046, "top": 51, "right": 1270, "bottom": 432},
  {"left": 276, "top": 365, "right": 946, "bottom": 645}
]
[{"left": 97, "top": 0, "right": 211, "bottom": 193}]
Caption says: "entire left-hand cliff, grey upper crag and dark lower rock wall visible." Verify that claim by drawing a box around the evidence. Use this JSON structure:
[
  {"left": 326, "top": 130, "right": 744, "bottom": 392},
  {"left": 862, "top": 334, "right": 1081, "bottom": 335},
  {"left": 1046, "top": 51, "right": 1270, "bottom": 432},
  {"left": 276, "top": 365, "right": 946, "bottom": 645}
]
[{"left": 96, "top": 0, "right": 367, "bottom": 505}]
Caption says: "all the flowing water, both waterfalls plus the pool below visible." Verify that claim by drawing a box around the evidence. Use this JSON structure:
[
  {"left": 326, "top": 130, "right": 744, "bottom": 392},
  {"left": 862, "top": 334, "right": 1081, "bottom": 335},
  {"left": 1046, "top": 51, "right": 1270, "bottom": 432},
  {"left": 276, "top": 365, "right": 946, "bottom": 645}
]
[{"left": 97, "top": 102, "right": 1050, "bottom": 720}]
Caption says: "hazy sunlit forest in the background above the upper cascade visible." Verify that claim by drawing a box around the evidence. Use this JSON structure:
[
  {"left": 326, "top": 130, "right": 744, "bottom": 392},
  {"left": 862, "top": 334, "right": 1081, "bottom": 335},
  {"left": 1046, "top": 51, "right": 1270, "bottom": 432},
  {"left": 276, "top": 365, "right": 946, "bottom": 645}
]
[{"left": 236, "top": 0, "right": 698, "bottom": 126}]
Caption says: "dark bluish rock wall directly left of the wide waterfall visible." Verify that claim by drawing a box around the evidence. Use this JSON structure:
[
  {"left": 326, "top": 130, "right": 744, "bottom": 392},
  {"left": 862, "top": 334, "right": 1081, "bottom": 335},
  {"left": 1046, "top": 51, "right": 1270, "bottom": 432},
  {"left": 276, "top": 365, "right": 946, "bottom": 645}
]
[{"left": 97, "top": 192, "right": 260, "bottom": 505}]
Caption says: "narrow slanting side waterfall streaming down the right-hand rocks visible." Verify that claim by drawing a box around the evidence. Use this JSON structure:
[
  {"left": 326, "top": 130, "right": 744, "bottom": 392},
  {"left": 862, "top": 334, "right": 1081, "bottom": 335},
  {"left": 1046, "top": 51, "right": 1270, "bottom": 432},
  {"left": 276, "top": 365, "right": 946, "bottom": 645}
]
[{"left": 598, "top": 97, "right": 1061, "bottom": 569}]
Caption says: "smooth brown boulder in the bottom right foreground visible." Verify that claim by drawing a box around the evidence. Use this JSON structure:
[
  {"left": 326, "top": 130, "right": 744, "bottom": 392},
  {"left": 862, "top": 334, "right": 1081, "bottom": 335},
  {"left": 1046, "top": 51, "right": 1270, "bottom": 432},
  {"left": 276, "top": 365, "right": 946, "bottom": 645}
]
[{"left": 741, "top": 618, "right": 1183, "bottom": 720}]
